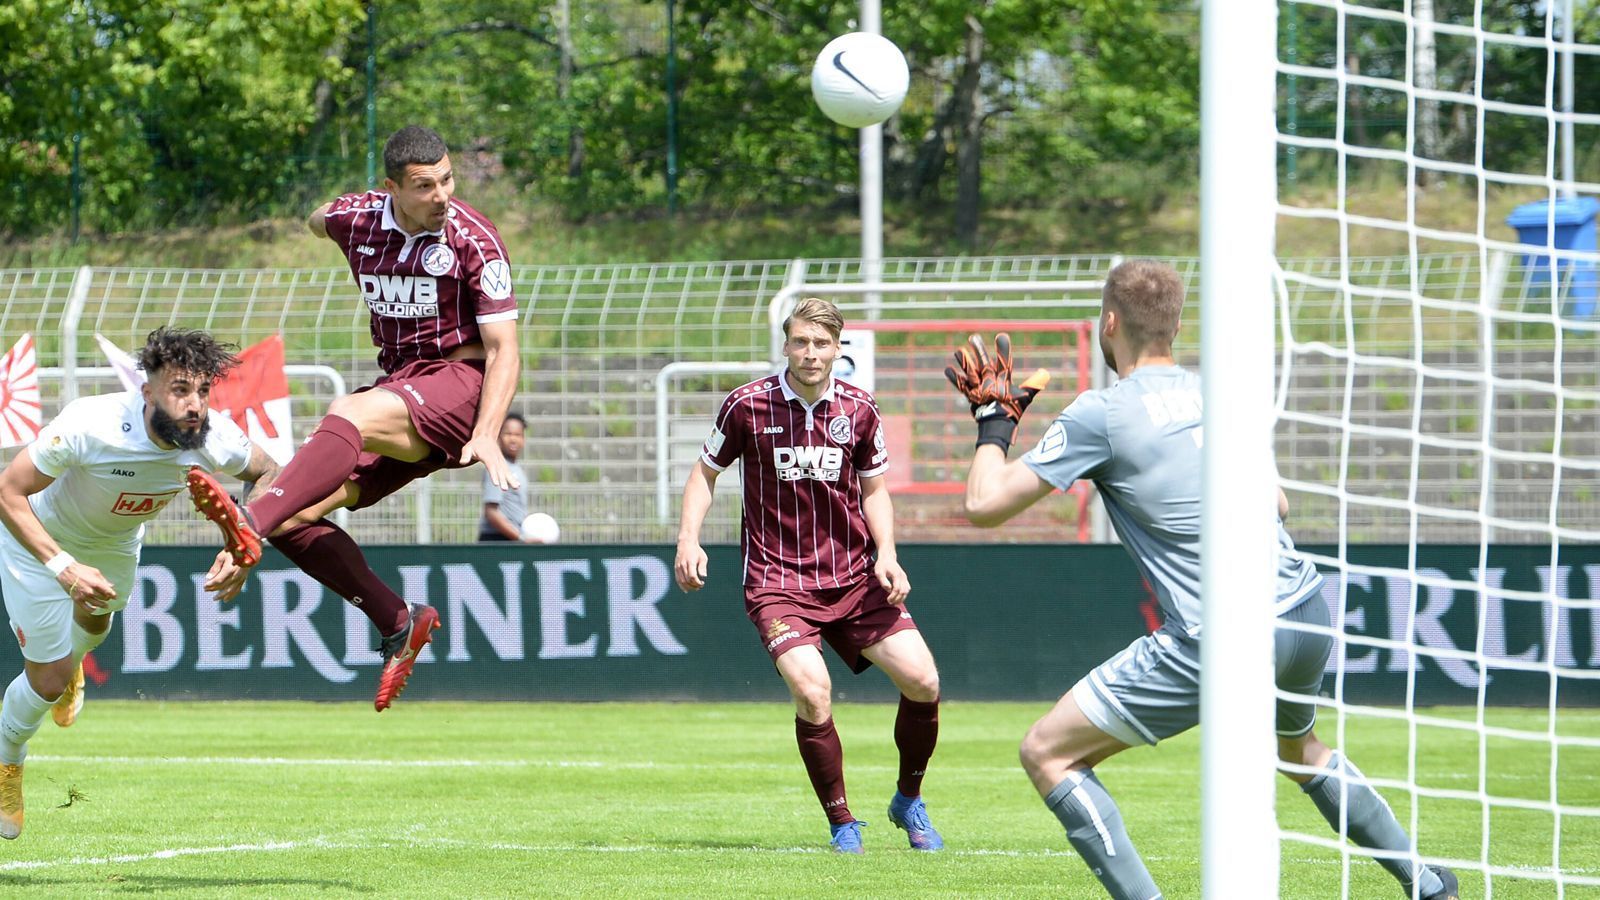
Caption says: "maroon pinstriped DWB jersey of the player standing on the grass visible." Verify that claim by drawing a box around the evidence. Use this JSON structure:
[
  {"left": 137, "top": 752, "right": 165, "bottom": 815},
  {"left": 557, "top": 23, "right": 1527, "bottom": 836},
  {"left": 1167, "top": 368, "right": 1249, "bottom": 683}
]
[{"left": 701, "top": 373, "right": 890, "bottom": 591}]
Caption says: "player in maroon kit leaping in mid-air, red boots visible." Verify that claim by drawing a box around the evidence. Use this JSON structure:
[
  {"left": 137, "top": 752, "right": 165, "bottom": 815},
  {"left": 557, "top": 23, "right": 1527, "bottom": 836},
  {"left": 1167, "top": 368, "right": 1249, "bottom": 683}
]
[{"left": 190, "top": 125, "right": 520, "bottom": 711}]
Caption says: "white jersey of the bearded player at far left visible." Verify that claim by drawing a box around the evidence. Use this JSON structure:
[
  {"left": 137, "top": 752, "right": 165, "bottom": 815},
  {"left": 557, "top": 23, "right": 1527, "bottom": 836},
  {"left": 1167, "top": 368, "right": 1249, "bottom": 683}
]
[{"left": 27, "top": 391, "right": 251, "bottom": 549}]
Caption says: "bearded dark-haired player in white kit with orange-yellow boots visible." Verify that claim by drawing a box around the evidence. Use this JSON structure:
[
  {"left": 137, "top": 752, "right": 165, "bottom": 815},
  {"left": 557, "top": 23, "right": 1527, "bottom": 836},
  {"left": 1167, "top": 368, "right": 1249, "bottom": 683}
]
[{"left": 0, "top": 327, "right": 278, "bottom": 839}]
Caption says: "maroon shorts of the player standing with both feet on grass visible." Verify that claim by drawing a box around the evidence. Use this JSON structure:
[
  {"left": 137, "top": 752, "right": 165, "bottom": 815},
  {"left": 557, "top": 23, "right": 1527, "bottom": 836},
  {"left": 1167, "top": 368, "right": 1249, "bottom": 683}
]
[{"left": 744, "top": 575, "right": 917, "bottom": 674}]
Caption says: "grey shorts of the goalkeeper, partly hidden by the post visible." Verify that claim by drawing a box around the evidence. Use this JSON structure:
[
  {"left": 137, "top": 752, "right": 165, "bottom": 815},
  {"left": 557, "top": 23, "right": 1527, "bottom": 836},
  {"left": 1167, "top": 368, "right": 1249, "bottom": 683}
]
[{"left": 1072, "top": 593, "right": 1334, "bottom": 746}]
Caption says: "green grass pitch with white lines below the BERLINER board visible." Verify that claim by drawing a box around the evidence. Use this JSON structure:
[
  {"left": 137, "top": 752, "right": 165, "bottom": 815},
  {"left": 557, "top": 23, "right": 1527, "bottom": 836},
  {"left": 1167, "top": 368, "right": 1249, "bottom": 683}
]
[{"left": 0, "top": 692, "right": 1600, "bottom": 898}]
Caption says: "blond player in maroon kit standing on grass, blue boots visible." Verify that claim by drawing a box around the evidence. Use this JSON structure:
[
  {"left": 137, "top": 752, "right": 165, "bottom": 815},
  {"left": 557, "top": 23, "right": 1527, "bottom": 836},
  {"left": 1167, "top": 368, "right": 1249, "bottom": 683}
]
[{"left": 674, "top": 298, "right": 944, "bottom": 854}]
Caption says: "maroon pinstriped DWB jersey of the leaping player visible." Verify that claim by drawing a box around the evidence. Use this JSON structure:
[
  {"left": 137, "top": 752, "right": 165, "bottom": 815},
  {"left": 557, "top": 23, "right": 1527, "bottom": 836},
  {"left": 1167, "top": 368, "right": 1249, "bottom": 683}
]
[{"left": 323, "top": 191, "right": 517, "bottom": 373}]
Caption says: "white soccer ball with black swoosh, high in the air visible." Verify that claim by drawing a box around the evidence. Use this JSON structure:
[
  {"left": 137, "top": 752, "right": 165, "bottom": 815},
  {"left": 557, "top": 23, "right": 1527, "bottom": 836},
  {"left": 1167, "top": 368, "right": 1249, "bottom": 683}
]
[{"left": 811, "top": 32, "right": 910, "bottom": 128}]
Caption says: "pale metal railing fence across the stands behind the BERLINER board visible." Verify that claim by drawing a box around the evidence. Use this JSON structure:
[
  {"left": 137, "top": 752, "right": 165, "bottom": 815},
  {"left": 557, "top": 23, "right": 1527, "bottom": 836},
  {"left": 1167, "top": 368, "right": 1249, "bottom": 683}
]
[{"left": 0, "top": 255, "right": 1600, "bottom": 543}]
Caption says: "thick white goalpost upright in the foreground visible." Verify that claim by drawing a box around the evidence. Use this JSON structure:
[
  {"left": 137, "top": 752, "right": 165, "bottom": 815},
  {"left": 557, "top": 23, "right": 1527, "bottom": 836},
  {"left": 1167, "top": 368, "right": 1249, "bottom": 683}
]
[{"left": 1200, "top": 0, "right": 1278, "bottom": 900}]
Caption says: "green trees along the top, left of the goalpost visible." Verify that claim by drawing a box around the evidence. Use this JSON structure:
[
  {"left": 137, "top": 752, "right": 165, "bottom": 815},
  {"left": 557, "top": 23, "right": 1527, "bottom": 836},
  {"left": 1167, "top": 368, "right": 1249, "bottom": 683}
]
[{"left": 0, "top": 0, "right": 1197, "bottom": 240}]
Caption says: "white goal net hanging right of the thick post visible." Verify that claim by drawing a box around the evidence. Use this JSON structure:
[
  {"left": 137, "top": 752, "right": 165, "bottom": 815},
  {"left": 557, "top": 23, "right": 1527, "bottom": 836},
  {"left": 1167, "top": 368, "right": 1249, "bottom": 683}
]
[{"left": 1202, "top": 0, "right": 1600, "bottom": 897}]
